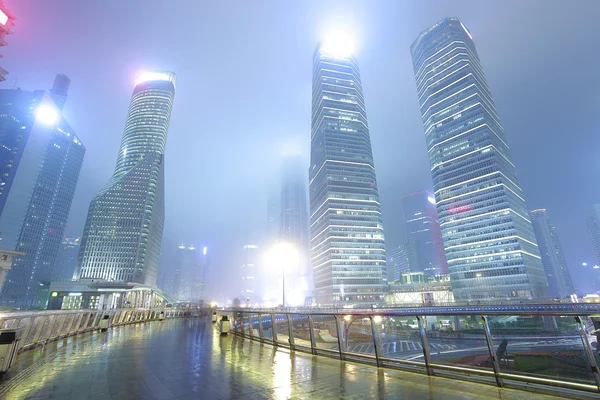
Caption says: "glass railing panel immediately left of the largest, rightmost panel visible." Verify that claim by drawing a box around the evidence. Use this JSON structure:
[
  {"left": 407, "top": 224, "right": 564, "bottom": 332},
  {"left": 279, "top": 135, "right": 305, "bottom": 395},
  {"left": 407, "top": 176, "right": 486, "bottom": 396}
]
[{"left": 426, "top": 315, "right": 493, "bottom": 371}]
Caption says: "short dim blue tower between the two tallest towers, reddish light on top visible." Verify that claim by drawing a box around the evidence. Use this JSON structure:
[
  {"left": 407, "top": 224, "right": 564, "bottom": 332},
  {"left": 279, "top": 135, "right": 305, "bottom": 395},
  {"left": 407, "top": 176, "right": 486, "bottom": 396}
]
[{"left": 401, "top": 190, "right": 448, "bottom": 278}]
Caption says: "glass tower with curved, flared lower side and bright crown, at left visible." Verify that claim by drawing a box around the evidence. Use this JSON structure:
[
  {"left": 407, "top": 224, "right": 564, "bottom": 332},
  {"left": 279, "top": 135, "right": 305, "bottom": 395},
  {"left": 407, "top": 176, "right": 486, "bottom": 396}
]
[{"left": 76, "top": 72, "right": 175, "bottom": 286}]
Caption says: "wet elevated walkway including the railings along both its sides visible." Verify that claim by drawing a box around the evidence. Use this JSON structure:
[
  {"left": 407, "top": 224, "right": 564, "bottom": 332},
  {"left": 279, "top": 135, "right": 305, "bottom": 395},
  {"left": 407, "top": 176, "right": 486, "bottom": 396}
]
[{"left": 0, "top": 306, "right": 600, "bottom": 399}]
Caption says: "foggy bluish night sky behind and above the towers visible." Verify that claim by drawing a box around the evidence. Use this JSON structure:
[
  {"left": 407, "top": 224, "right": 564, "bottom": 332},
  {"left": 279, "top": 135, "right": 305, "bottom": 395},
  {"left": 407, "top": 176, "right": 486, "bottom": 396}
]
[{"left": 0, "top": 0, "right": 600, "bottom": 299}]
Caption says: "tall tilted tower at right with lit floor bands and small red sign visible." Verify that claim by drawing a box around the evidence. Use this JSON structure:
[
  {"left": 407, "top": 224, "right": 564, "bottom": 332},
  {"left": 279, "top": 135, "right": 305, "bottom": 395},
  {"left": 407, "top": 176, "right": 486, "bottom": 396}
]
[{"left": 411, "top": 18, "right": 548, "bottom": 300}]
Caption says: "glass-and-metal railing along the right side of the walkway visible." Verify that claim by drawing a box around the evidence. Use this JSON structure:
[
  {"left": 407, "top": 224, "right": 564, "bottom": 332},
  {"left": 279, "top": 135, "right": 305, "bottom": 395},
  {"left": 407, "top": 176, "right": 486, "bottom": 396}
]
[{"left": 225, "top": 303, "right": 600, "bottom": 394}]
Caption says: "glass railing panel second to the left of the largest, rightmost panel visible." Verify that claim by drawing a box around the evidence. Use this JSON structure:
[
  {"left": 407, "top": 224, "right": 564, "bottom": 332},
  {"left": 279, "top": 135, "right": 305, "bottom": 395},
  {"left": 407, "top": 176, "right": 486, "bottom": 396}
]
[{"left": 375, "top": 316, "right": 425, "bottom": 365}]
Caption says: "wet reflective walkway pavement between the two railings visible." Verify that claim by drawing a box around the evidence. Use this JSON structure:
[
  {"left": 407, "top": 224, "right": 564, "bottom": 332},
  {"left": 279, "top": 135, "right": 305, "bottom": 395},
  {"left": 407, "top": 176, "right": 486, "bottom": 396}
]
[{"left": 0, "top": 319, "right": 576, "bottom": 400}]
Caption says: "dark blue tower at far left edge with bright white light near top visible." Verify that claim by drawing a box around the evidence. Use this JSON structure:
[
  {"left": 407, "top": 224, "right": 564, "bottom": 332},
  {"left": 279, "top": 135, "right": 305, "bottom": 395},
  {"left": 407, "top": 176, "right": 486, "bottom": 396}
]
[{"left": 0, "top": 75, "right": 85, "bottom": 308}]
